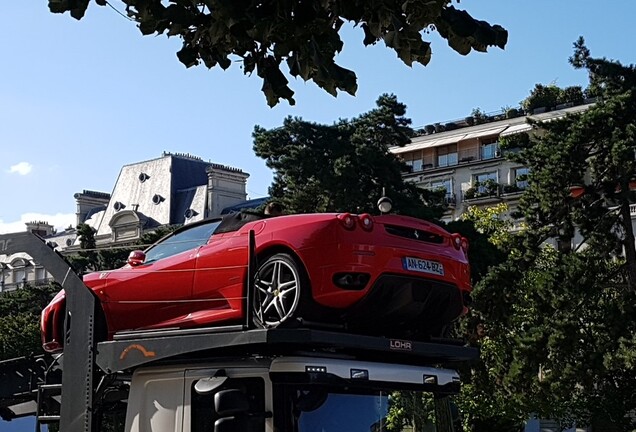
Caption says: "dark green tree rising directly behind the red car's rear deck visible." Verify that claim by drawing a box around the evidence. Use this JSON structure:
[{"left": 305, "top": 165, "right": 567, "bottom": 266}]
[{"left": 253, "top": 95, "right": 443, "bottom": 218}]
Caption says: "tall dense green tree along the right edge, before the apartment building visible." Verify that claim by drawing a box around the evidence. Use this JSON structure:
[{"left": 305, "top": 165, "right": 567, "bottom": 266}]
[{"left": 474, "top": 39, "right": 636, "bottom": 431}]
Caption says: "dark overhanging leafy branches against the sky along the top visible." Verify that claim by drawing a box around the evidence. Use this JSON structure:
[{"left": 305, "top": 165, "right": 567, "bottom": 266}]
[{"left": 49, "top": 0, "right": 508, "bottom": 106}]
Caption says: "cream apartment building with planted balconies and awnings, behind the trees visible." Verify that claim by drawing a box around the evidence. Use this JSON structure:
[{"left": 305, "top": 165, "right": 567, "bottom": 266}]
[{"left": 390, "top": 104, "right": 590, "bottom": 222}]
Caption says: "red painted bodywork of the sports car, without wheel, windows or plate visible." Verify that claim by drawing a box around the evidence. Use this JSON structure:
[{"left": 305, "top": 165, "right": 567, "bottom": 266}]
[{"left": 42, "top": 213, "right": 471, "bottom": 347}]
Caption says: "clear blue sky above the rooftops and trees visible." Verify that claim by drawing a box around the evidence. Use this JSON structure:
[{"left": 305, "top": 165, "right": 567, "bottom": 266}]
[{"left": 0, "top": 0, "right": 636, "bottom": 232}]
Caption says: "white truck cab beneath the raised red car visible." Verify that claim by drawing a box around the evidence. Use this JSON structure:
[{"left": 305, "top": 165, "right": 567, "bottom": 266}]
[{"left": 124, "top": 356, "right": 459, "bottom": 432}]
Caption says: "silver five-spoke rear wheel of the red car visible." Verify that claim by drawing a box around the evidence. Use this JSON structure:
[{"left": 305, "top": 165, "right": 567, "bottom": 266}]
[{"left": 252, "top": 253, "right": 309, "bottom": 328}]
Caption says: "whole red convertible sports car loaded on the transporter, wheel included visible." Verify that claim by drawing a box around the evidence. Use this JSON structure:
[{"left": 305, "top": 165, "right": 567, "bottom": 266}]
[{"left": 41, "top": 213, "right": 471, "bottom": 352}]
